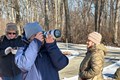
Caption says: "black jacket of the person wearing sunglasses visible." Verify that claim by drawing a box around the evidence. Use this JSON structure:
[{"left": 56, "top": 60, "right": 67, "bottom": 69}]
[{"left": 0, "top": 36, "right": 23, "bottom": 77}]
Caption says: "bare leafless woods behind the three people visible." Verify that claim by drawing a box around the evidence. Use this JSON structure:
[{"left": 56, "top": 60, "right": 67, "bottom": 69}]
[{"left": 0, "top": 0, "right": 120, "bottom": 46}]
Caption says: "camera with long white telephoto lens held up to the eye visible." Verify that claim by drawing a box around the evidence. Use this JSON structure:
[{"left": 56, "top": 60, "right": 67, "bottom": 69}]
[{"left": 42, "top": 29, "right": 61, "bottom": 38}]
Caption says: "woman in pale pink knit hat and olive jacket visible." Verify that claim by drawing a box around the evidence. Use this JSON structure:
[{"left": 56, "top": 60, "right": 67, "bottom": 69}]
[{"left": 78, "top": 32, "right": 106, "bottom": 80}]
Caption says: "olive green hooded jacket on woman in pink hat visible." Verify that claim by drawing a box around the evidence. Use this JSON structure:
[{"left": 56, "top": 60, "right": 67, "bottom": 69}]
[{"left": 78, "top": 44, "right": 107, "bottom": 80}]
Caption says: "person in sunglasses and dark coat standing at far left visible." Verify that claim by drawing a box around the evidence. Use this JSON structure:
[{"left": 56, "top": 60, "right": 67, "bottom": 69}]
[{"left": 0, "top": 23, "right": 23, "bottom": 80}]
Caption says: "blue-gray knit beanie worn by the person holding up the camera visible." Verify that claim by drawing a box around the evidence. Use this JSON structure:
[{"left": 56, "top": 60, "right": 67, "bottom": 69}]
[{"left": 24, "top": 22, "right": 42, "bottom": 39}]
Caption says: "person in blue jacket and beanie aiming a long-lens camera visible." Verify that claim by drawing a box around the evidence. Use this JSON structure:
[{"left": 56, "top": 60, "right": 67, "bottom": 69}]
[{"left": 15, "top": 22, "right": 68, "bottom": 80}]
